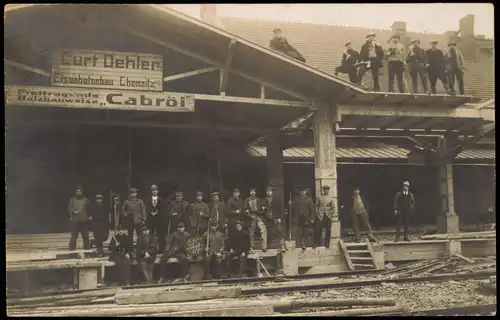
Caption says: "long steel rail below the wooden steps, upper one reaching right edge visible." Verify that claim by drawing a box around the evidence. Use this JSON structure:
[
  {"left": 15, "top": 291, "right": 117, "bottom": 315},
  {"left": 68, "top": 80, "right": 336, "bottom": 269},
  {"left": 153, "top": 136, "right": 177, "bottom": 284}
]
[{"left": 241, "top": 270, "right": 496, "bottom": 296}]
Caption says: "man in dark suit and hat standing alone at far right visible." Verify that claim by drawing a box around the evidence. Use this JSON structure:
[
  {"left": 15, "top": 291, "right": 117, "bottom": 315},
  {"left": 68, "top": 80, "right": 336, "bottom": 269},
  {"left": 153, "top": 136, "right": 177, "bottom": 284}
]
[{"left": 394, "top": 181, "right": 415, "bottom": 242}]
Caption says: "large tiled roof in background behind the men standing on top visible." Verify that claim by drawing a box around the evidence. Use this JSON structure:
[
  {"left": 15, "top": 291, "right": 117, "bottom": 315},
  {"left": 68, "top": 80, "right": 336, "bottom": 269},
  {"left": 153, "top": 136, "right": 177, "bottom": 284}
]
[{"left": 221, "top": 17, "right": 495, "bottom": 99}]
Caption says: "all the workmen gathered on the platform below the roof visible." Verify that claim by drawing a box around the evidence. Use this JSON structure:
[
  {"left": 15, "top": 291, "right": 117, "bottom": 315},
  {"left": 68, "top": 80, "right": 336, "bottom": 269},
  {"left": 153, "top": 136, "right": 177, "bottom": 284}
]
[{"left": 68, "top": 181, "right": 415, "bottom": 285}]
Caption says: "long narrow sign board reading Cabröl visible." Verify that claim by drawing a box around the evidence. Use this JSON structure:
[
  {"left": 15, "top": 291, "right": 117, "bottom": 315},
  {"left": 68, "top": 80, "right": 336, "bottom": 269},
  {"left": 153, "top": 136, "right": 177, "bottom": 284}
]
[{"left": 5, "top": 86, "right": 194, "bottom": 112}]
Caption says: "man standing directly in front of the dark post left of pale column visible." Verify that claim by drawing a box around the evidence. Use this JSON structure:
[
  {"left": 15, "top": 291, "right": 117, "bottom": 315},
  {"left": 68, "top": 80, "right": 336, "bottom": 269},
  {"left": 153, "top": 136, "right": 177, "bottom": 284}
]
[{"left": 262, "top": 187, "right": 285, "bottom": 250}]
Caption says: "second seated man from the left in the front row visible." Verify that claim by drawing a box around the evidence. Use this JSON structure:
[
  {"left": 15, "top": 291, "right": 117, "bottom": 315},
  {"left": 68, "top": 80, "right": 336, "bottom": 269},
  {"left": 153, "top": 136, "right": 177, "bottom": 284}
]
[{"left": 136, "top": 225, "right": 158, "bottom": 284}]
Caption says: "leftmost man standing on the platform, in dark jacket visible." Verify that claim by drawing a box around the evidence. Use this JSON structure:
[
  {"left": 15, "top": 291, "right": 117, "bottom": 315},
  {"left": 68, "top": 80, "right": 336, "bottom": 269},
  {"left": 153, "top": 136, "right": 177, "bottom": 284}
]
[{"left": 68, "top": 186, "right": 90, "bottom": 251}]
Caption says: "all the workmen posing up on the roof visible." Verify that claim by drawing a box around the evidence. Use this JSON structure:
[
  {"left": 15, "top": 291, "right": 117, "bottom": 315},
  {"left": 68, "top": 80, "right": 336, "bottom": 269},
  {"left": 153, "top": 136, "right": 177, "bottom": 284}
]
[{"left": 269, "top": 28, "right": 465, "bottom": 95}]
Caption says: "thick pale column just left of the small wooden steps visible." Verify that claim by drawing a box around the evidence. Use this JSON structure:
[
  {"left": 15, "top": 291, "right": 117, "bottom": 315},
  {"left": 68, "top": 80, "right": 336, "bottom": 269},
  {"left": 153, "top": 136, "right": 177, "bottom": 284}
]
[{"left": 313, "top": 105, "right": 340, "bottom": 248}]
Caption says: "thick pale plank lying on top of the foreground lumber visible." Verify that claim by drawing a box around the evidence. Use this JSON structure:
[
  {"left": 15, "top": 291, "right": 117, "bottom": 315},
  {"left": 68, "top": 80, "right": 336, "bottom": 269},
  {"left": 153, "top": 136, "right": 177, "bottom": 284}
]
[{"left": 115, "top": 288, "right": 241, "bottom": 305}]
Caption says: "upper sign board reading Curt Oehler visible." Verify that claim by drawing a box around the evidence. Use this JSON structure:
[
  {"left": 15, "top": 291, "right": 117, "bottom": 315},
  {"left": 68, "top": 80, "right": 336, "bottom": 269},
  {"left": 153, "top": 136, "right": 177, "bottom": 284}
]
[{"left": 52, "top": 49, "right": 163, "bottom": 92}]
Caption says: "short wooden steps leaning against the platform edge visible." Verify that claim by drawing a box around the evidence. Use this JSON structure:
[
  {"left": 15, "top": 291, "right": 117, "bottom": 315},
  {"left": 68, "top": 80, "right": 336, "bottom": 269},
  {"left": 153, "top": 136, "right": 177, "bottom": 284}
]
[{"left": 339, "top": 240, "right": 377, "bottom": 271}]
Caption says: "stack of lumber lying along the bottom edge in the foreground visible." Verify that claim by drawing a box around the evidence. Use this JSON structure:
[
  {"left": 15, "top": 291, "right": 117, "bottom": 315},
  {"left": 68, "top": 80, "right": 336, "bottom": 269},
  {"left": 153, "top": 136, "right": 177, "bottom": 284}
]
[{"left": 7, "top": 284, "right": 402, "bottom": 317}]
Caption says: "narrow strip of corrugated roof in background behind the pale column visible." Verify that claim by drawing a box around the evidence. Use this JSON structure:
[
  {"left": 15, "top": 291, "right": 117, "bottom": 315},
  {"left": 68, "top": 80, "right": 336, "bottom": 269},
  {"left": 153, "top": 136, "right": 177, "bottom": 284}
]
[{"left": 247, "top": 146, "right": 495, "bottom": 160}]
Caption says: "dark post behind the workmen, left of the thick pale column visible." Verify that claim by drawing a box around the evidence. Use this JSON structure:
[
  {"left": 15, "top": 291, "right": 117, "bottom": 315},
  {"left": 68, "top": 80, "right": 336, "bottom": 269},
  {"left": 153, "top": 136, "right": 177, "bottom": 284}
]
[{"left": 266, "top": 129, "right": 285, "bottom": 252}]
